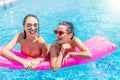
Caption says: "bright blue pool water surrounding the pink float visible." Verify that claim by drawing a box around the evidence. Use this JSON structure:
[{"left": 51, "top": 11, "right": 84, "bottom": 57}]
[{"left": 0, "top": 0, "right": 120, "bottom": 80}]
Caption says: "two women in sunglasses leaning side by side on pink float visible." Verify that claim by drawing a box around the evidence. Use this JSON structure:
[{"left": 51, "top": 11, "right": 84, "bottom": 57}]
[{"left": 1, "top": 14, "right": 92, "bottom": 71}]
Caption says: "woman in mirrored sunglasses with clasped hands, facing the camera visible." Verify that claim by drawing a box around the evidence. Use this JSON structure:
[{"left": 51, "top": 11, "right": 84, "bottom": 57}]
[{"left": 1, "top": 14, "right": 48, "bottom": 70}]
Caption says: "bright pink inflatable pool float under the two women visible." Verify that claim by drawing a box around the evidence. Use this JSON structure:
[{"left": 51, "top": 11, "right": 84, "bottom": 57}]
[{"left": 0, "top": 36, "right": 116, "bottom": 70}]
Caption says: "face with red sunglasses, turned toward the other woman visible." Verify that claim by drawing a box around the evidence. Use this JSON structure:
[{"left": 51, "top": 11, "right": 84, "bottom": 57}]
[{"left": 54, "top": 25, "right": 71, "bottom": 44}]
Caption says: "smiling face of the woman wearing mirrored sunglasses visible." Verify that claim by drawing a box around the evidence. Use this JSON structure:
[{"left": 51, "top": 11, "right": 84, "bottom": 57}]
[{"left": 24, "top": 16, "right": 38, "bottom": 36}]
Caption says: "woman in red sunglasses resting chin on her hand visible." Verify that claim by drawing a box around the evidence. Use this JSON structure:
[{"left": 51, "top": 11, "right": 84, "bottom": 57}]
[{"left": 50, "top": 22, "right": 92, "bottom": 71}]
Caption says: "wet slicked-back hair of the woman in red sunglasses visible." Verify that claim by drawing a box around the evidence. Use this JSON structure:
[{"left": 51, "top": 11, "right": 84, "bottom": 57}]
[{"left": 58, "top": 21, "right": 74, "bottom": 39}]
